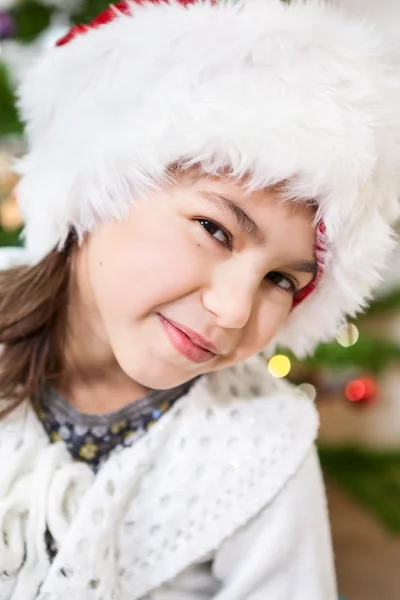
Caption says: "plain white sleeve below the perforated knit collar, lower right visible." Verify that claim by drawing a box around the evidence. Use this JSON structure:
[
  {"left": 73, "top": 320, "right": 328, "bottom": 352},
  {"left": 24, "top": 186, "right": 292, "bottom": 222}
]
[{"left": 213, "top": 448, "right": 337, "bottom": 600}]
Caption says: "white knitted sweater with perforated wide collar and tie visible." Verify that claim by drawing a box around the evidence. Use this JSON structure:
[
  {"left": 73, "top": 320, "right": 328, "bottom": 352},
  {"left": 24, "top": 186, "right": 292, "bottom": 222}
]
[{"left": 0, "top": 358, "right": 336, "bottom": 600}]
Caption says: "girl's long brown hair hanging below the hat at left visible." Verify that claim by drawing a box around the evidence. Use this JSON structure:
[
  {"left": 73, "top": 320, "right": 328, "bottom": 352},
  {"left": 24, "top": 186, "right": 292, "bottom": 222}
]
[{"left": 0, "top": 237, "right": 74, "bottom": 418}]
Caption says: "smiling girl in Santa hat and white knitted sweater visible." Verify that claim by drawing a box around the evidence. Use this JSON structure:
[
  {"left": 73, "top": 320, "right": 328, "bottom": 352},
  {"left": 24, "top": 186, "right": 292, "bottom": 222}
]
[{"left": 0, "top": 0, "right": 400, "bottom": 600}]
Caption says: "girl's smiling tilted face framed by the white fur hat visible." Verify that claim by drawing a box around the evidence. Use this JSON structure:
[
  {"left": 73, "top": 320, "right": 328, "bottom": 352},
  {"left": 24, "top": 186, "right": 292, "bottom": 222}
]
[{"left": 80, "top": 178, "right": 316, "bottom": 389}]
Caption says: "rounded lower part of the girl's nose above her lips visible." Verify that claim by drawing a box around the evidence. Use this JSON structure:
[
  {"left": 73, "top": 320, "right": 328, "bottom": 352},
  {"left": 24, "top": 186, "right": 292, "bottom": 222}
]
[{"left": 203, "top": 268, "right": 260, "bottom": 329}]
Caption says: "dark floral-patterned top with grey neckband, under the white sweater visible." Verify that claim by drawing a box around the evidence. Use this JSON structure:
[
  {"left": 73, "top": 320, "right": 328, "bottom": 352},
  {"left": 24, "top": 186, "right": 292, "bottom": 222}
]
[{"left": 38, "top": 381, "right": 193, "bottom": 471}]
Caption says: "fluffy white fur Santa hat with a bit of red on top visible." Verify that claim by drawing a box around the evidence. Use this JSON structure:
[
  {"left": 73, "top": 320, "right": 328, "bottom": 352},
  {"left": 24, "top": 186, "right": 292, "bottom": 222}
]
[{"left": 14, "top": 0, "right": 400, "bottom": 355}]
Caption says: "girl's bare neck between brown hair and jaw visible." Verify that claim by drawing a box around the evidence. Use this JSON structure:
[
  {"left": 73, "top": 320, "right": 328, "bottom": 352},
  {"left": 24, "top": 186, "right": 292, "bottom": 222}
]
[{"left": 59, "top": 247, "right": 149, "bottom": 414}]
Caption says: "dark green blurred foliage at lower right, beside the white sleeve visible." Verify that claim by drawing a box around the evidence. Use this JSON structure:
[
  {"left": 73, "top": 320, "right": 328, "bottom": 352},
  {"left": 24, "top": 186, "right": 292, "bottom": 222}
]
[{"left": 320, "top": 448, "right": 400, "bottom": 534}]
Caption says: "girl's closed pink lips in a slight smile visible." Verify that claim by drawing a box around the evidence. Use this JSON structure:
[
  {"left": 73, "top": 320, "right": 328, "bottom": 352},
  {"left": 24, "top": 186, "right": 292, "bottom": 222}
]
[{"left": 159, "top": 315, "right": 218, "bottom": 363}]
